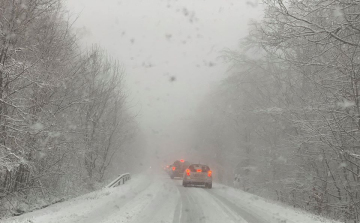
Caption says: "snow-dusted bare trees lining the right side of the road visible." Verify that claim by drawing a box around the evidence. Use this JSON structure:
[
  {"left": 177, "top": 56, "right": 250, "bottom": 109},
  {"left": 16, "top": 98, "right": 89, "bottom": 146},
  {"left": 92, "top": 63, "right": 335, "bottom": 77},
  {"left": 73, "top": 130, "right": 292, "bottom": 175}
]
[{"left": 195, "top": 0, "right": 360, "bottom": 222}]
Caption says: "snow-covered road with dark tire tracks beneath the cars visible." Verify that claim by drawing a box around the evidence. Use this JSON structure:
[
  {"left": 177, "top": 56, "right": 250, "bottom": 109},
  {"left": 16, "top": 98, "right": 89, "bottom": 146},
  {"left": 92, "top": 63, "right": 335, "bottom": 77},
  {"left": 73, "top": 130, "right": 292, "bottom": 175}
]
[{"left": 3, "top": 174, "right": 340, "bottom": 223}]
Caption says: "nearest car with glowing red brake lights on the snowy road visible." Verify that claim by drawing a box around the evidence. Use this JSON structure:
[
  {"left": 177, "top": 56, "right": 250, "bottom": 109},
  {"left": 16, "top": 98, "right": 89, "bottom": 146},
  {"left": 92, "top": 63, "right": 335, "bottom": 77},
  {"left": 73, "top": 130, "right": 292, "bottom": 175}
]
[{"left": 183, "top": 164, "right": 212, "bottom": 188}]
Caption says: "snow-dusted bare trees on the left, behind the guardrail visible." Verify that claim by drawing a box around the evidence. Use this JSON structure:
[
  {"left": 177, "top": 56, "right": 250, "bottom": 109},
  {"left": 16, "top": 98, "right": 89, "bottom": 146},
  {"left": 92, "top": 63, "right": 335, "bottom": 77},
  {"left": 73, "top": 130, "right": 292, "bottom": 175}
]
[{"left": 0, "top": 0, "right": 143, "bottom": 217}]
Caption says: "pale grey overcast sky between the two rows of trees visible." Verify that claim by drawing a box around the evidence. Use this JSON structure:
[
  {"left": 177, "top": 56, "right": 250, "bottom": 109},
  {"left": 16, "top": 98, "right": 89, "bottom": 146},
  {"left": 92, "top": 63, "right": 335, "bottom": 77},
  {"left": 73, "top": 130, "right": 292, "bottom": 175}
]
[{"left": 67, "top": 0, "right": 261, "bottom": 161}]
